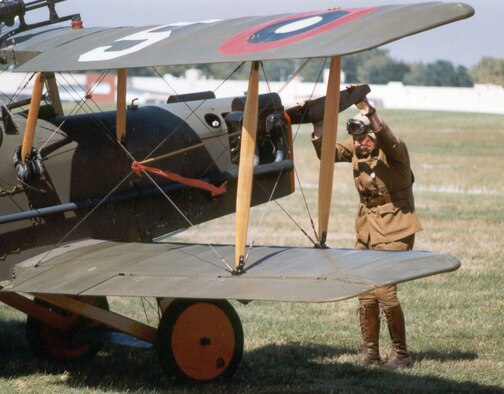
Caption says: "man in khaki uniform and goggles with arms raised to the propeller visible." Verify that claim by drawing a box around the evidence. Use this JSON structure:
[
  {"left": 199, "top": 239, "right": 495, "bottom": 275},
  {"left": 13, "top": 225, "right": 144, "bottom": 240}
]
[{"left": 312, "top": 95, "right": 422, "bottom": 369}]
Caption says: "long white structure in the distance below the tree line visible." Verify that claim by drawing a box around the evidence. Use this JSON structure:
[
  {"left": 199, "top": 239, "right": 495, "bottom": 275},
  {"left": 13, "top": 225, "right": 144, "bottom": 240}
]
[{"left": 0, "top": 70, "right": 504, "bottom": 114}]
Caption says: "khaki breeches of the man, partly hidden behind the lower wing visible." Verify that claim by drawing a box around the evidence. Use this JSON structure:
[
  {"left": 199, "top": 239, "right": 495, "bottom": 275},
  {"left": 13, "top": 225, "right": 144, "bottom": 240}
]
[{"left": 355, "top": 234, "right": 415, "bottom": 309}]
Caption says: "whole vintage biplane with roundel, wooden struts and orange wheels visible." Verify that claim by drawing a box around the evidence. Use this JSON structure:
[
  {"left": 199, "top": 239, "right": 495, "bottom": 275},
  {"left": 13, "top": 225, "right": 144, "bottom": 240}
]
[{"left": 0, "top": 0, "right": 474, "bottom": 382}]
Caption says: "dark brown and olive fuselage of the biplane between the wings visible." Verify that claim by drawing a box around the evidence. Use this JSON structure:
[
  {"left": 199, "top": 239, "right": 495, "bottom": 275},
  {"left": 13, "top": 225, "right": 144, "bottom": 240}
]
[{"left": 0, "top": 94, "right": 293, "bottom": 280}]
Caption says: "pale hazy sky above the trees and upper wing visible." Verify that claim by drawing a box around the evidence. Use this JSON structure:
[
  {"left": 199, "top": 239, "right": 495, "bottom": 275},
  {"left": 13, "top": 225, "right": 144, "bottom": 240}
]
[{"left": 33, "top": 0, "right": 504, "bottom": 67}]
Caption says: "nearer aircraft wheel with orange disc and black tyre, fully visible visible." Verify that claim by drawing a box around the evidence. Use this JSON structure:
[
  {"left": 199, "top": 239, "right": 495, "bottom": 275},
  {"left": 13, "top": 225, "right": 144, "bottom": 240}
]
[{"left": 157, "top": 299, "right": 243, "bottom": 382}]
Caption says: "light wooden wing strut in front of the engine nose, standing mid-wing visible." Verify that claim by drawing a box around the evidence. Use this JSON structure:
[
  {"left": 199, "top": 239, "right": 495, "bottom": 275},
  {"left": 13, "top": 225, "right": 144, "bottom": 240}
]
[{"left": 235, "top": 62, "right": 259, "bottom": 273}]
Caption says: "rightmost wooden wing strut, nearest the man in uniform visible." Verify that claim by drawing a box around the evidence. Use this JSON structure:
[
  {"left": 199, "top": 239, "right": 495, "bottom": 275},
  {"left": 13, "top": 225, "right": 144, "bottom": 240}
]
[{"left": 318, "top": 56, "right": 341, "bottom": 248}]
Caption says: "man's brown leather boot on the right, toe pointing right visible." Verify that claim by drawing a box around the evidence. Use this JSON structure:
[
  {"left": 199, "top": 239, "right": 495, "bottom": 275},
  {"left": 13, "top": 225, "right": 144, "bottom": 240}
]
[{"left": 383, "top": 305, "right": 413, "bottom": 370}]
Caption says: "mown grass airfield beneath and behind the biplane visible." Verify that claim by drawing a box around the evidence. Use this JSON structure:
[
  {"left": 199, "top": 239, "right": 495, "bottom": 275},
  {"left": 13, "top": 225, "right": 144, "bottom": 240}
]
[{"left": 0, "top": 111, "right": 504, "bottom": 393}]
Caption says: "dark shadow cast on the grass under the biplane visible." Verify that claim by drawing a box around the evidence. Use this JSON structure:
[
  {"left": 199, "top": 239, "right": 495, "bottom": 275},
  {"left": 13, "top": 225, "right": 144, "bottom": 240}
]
[{"left": 0, "top": 322, "right": 504, "bottom": 393}]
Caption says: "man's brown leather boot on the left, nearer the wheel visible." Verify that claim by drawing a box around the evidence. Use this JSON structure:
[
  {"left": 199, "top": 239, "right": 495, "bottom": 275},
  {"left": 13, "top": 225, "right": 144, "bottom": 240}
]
[{"left": 359, "top": 304, "right": 381, "bottom": 366}]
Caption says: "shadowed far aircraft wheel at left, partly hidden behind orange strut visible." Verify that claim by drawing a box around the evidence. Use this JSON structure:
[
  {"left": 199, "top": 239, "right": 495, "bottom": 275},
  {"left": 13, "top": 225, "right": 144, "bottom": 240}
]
[{"left": 26, "top": 297, "right": 109, "bottom": 363}]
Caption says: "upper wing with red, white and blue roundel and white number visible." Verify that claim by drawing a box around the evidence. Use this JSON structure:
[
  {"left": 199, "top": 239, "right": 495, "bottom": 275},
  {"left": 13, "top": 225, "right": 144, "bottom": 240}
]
[{"left": 0, "top": 2, "right": 474, "bottom": 72}]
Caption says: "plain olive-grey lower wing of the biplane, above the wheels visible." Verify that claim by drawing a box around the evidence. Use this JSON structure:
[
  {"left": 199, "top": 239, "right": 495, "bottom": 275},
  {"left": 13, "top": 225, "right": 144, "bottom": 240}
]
[{"left": 4, "top": 240, "right": 460, "bottom": 302}]
